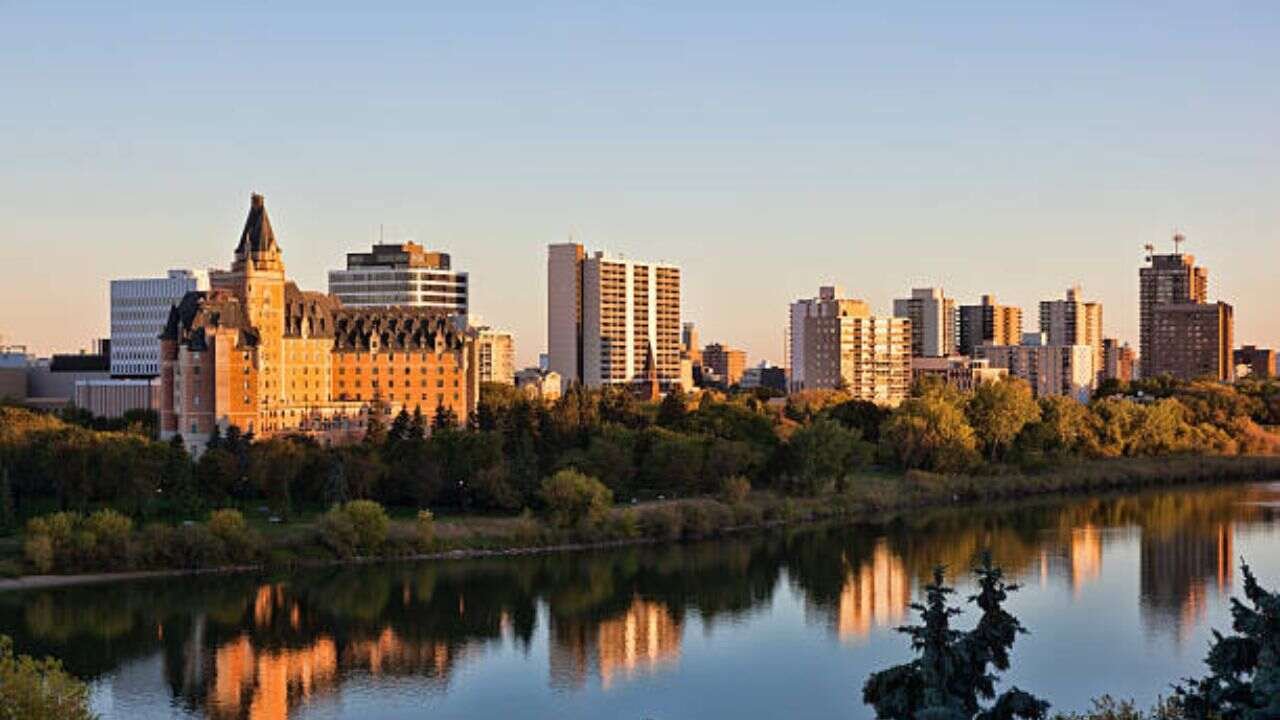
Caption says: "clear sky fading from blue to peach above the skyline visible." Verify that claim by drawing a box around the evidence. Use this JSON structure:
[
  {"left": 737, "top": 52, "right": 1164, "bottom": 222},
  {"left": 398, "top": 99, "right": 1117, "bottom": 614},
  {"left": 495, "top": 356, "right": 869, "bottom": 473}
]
[{"left": 0, "top": 0, "right": 1280, "bottom": 364}]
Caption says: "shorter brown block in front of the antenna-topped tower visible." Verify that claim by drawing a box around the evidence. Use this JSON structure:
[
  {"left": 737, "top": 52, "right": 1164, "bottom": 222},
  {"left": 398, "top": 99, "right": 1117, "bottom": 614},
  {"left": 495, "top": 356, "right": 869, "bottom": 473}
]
[{"left": 1142, "top": 302, "right": 1235, "bottom": 380}]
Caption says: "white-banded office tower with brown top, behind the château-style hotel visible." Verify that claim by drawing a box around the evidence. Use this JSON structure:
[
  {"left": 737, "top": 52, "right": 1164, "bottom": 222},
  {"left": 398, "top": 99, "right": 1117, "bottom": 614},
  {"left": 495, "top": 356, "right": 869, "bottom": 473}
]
[{"left": 329, "top": 242, "right": 467, "bottom": 315}]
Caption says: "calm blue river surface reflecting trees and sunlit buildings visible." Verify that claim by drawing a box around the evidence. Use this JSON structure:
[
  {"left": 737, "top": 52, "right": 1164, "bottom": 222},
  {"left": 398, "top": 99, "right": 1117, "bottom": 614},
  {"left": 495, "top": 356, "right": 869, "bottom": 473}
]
[{"left": 0, "top": 483, "right": 1280, "bottom": 720}]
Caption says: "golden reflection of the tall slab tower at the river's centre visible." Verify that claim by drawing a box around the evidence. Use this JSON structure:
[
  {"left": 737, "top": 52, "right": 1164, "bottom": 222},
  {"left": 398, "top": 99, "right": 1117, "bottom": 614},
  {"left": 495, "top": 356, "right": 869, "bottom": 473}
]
[{"left": 548, "top": 597, "right": 684, "bottom": 689}]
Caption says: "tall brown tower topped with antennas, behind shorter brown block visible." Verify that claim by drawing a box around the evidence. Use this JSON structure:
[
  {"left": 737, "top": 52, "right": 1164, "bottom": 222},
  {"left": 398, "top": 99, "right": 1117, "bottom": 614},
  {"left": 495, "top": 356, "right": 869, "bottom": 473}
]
[{"left": 1138, "top": 234, "right": 1208, "bottom": 377}]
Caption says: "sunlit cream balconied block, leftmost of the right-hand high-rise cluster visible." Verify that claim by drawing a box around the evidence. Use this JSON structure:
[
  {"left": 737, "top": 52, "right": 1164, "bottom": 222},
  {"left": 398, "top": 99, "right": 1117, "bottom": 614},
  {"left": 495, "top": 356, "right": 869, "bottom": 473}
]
[{"left": 791, "top": 287, "right": 911, "bottom": 405}]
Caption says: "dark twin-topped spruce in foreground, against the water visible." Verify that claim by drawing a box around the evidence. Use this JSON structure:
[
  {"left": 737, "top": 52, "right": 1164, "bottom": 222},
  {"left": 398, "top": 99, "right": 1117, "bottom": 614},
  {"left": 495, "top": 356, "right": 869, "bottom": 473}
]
[{"left": 863, "top": 553, "right": 1048, "bottom": 720}]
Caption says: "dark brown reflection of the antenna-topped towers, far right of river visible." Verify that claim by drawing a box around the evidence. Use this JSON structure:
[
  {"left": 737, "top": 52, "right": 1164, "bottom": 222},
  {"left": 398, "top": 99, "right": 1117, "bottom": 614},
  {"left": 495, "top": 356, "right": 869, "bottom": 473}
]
[{"left": 1139, "top": 523, "right": 1235, "bottom": 641}]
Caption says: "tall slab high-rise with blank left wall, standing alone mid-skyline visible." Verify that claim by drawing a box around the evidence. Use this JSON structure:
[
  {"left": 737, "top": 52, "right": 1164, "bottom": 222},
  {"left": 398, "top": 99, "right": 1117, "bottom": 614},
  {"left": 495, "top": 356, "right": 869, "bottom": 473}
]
[{"left": 547, "top": 242, "right": 681, "bottom": 389}]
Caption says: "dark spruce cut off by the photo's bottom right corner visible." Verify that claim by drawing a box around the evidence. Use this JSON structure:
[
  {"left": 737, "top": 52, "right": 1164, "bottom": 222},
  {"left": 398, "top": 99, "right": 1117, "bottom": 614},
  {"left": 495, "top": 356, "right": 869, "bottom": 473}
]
[{"left": 1174, "top": 565, "right": 1280, "bottom": 720}]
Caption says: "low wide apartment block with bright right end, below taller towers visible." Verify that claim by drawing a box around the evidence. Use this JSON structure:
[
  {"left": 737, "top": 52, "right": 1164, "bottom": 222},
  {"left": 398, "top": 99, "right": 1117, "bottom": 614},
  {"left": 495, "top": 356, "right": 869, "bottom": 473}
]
[{"left": 975, "top": 345, "right": 1097, "bottom": 402}]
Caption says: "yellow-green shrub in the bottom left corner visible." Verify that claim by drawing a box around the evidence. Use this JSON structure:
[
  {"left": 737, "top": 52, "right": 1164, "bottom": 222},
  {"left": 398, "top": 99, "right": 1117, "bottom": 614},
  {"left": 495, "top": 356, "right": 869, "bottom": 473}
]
[{"left": 0, "top": 635, "right": 93, "bottom": 720}]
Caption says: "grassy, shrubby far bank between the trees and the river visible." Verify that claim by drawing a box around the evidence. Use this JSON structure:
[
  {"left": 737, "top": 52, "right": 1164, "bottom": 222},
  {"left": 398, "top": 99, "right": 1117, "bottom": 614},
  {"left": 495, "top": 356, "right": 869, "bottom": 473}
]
[{"left": 0, "top": 456, "right": 1280, "bottom": 587}]
